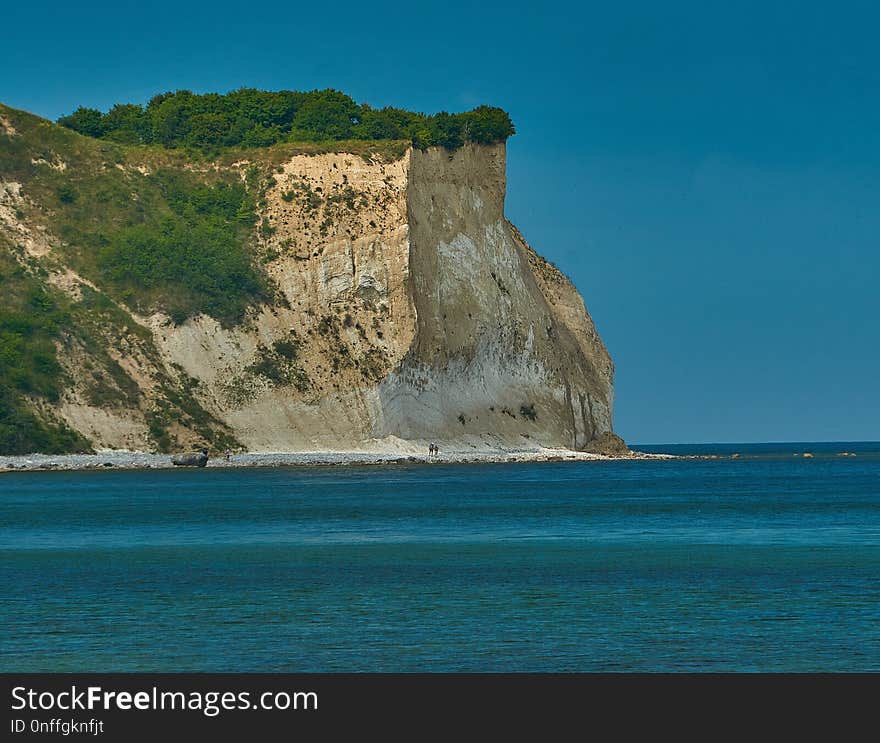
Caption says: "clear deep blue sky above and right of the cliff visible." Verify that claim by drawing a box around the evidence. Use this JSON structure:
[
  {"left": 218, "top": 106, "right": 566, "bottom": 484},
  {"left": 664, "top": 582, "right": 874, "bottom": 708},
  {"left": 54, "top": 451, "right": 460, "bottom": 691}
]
[{"left": 0, "top": 0, "right": 880, "bottom": 443}]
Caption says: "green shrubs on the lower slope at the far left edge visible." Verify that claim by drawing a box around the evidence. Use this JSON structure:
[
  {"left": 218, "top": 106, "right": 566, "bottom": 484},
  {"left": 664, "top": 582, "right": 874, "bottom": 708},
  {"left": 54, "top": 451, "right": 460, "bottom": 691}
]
[{"left": 0, "top": 253, "right": 90, "bottom": 454}]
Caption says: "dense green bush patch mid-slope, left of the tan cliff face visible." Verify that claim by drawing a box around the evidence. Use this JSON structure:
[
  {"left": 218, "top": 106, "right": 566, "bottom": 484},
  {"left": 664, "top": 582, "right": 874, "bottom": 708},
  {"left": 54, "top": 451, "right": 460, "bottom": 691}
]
[{"left": 97, "top": 171, "right": 263, "bottom": 322}]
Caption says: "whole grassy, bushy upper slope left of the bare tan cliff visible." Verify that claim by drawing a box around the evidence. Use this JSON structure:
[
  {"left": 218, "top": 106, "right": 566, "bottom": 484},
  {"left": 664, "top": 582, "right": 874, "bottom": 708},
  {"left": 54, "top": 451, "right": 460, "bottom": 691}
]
[{"left": 0, "top": 109, "right": 267, "bottom": 325}]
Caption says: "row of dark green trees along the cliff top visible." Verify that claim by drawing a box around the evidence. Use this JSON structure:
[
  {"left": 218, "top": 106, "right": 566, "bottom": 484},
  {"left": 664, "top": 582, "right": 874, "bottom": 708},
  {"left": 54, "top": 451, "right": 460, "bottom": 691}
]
[{"left": 58, "top": 89, "right": 514, "bottom": 153}]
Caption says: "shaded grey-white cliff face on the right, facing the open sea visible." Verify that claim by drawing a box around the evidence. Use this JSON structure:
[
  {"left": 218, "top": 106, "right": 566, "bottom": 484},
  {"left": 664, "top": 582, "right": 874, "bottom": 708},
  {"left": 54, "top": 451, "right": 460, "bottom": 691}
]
[{"left": 375, "top": 145, "right": 613, "bottom": 448}]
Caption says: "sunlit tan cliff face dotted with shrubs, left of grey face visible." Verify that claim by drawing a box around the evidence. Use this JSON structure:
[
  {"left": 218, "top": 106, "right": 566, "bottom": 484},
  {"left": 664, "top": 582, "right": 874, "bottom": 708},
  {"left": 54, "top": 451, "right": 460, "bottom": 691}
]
[{"left": 154, "top": 154, "right": 415, "bottom": 451}]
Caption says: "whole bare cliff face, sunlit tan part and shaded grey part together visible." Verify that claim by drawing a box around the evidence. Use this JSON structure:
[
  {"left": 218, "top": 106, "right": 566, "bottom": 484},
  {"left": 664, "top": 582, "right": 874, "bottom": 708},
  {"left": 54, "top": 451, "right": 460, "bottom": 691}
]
[{"left": 148, "top": 145, "right": 613, "bottom": 451}]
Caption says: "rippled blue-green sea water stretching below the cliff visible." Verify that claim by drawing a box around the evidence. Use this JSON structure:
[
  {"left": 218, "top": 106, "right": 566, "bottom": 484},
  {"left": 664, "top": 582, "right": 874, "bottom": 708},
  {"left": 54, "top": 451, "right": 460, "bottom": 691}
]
[{"left": 0, "top": 443, "right": 880, "bottom": 672}]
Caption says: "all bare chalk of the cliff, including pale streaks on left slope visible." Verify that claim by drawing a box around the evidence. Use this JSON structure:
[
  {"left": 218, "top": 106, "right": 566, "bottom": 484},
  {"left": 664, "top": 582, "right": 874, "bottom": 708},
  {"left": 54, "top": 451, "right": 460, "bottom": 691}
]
[{"left": 0, "top": 103, "right": 613, "bottom": 451}]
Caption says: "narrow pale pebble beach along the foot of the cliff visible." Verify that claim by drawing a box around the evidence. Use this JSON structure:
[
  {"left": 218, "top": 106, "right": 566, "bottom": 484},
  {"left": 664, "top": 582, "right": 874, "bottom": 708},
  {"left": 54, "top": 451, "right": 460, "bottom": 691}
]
[{"left": 0, "top": 448, "right": 679, "bottom": 473}]
